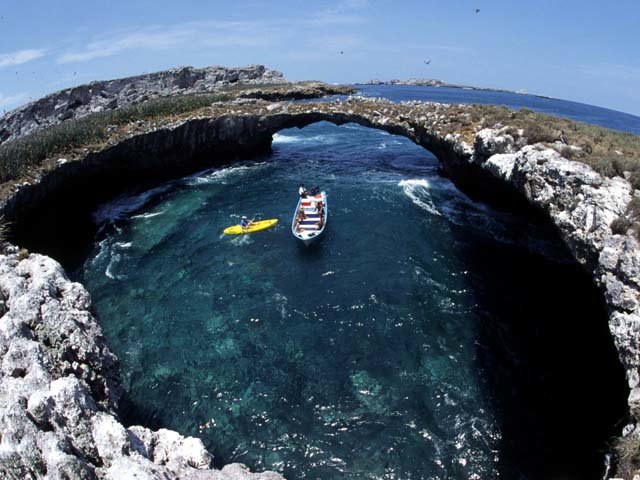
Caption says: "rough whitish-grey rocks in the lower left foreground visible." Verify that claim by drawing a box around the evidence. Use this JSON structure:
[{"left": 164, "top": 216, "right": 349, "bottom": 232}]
[{"left": 0, "top": 247, "right": 282, "bottom": 480}]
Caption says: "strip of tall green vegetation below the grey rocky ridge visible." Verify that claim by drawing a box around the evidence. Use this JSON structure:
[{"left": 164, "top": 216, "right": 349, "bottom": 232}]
[{"left": 0, "top": 94, "right": 229, "bottom": 182}]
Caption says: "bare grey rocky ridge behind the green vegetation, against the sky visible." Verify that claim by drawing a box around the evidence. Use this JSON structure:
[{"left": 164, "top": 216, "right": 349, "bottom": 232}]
[{"left": 0, "top": 65, "right": 285, "bottom": 143}]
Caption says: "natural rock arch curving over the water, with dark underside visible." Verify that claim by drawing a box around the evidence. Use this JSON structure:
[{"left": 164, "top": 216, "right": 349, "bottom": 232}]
[{"left": 0, "top": 98, "right": 640, "bottom": 478}]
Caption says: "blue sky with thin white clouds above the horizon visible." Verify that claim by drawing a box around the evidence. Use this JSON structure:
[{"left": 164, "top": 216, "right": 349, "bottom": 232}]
[{"left": 0, "top": 0, "right": 640, "bottom": 115}]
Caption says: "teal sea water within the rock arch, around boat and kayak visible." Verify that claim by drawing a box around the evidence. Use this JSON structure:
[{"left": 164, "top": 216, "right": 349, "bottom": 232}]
[{"left": 77, "top": 87, "right": 625, "bottom": 479}]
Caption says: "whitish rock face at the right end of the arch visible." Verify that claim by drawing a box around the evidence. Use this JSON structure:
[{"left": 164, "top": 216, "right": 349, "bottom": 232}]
[{"left": 472, "top": 130, "right": 640, "bottom": 408}]
